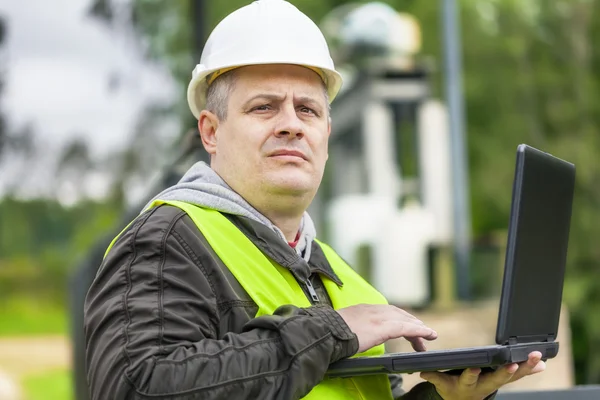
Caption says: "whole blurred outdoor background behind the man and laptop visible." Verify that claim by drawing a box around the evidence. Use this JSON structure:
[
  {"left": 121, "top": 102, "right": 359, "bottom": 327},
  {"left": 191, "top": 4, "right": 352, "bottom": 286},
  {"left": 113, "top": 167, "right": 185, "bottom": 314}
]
[{"left": 0, "top": 0, "right": 600, "bottom": 400}]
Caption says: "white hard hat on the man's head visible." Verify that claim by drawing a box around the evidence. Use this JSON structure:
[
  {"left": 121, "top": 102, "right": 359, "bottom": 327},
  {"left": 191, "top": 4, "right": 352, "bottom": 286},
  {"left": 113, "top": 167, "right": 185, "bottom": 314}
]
[{"left": 187, "top": 0, "right": 342, "bottom": 118}]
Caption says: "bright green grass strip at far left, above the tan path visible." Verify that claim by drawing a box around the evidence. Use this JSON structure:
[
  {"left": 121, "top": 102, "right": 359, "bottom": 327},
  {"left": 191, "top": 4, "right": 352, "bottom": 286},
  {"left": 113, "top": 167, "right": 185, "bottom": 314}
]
[{"left": 0, "top": 298, "right": 69, "bottom": 336}]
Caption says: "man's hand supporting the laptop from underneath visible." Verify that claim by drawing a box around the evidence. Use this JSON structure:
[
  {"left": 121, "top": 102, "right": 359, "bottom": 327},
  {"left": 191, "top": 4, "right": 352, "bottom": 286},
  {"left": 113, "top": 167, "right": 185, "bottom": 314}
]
[{"left": 421, "top": 351, "right": 546, "bottom": 400}]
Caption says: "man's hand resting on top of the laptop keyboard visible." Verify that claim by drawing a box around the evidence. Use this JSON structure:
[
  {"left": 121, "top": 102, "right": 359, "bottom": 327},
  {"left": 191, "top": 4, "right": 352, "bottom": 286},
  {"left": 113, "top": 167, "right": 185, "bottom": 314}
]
[{"left": 338, "top": 304, "right": 437, "bottom": 353}]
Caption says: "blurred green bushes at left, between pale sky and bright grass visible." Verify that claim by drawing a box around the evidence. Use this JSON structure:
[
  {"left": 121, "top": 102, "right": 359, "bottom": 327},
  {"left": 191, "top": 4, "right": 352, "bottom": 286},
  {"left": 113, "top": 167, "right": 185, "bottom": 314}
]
[{"left": 0, "top": 198, "right": 120, "bottom": 306}]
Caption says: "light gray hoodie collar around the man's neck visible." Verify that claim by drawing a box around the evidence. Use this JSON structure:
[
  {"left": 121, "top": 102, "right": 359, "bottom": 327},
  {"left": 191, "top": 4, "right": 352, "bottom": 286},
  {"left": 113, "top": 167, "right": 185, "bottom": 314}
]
[{"left": 144, "top": 161, "right": 316, "bottom": 261}]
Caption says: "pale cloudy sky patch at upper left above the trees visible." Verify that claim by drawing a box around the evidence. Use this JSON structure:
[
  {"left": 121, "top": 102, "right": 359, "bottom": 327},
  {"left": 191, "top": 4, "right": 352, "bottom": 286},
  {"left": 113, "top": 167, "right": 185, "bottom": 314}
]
[{"left": 0, "top": 0, "right": 177, "bottom": 199}]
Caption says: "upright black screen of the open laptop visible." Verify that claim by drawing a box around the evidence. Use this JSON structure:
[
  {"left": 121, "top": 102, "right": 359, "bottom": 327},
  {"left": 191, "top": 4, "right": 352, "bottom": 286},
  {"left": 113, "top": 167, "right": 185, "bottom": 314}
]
[{"left": 496, "top": 145, "right": 575, "bottom": 344}]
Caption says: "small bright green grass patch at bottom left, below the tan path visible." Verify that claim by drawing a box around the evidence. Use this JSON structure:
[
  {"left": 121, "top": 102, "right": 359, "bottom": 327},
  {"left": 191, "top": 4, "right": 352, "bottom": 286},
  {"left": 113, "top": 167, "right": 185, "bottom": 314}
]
[{"left": 23, "top": 370, "right": 73, "bottom": 400}]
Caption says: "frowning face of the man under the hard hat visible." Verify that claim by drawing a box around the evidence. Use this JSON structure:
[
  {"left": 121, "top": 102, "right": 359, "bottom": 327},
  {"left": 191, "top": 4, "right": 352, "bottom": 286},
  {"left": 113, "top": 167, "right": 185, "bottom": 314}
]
[{"left": 208, "top": 65, "right": 330, "bottom": 208}]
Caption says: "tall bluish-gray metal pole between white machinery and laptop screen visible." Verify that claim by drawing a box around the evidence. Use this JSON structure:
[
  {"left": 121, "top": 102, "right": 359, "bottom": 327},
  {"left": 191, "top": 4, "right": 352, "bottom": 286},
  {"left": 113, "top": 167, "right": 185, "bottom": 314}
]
[{"left": 441, "top": 0, "right": 471, "bottom": 300}]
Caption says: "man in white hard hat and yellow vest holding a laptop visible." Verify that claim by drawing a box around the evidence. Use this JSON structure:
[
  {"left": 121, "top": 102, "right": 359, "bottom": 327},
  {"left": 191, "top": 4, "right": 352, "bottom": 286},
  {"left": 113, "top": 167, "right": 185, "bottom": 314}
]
[{"left": 85, "top": 0, "right": 544, "bottom": 400}]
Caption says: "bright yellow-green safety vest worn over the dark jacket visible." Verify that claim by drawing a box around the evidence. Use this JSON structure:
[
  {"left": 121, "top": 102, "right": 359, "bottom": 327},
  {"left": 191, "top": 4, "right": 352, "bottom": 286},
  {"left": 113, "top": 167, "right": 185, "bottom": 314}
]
[{"left": 110, "top": 200, "right": 392, "bottom": 400}]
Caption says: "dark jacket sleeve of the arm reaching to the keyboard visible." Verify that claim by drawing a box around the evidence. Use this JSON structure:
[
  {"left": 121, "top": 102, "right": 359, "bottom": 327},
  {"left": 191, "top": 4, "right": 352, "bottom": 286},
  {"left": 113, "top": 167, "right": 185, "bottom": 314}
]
[{"left": 84, "top": 211, "right": 358, "bottom": 400}]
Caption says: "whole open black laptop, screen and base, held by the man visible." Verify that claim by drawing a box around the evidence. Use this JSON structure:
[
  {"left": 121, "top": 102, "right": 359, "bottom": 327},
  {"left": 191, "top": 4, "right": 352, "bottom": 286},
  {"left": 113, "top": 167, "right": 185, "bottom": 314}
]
[{"left": 327, "top": 144, "right": 575, "bottom": 377}]
